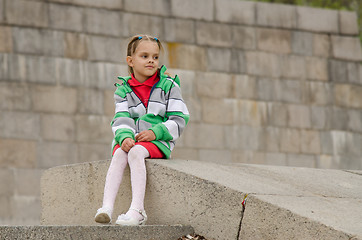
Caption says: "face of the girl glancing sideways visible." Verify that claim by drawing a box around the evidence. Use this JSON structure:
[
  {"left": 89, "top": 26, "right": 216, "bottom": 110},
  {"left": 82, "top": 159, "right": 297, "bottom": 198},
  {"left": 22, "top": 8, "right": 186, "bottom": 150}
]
[{"left": 127, "top": 41, "right": 160, "bottom": 83}]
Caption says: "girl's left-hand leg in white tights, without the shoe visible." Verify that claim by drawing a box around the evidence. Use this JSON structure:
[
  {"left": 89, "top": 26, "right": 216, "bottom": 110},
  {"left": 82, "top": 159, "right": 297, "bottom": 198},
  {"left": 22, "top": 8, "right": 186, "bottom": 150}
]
[{"left": 102, "top": 148, "right": 128, "bottom": 212}]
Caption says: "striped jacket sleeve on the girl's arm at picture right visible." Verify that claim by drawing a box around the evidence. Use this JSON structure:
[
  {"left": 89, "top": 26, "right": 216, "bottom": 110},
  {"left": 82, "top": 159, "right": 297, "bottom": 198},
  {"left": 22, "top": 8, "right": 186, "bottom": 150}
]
[{"left": 150, "top": 82, "right": 190, "bottom": 141}]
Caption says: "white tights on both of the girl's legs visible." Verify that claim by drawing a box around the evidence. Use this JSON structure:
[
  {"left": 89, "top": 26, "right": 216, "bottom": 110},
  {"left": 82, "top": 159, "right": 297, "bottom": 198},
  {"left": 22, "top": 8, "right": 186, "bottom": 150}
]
[{"left": 102, "top": 145, "right": 149, "bottom": 220}]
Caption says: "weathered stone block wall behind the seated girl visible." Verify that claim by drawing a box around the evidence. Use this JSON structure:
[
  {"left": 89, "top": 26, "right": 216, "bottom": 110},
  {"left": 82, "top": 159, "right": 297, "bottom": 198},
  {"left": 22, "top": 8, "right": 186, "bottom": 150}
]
[{"left": 0, "top": 0, "right": 362, "bottom": 224}]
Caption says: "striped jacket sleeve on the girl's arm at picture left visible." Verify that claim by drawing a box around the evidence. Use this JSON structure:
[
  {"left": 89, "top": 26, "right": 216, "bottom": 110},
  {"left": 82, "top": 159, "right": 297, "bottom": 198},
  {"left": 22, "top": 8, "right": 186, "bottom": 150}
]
[{"left": 111, "top": 86, "right": 136, "bottom": 144}]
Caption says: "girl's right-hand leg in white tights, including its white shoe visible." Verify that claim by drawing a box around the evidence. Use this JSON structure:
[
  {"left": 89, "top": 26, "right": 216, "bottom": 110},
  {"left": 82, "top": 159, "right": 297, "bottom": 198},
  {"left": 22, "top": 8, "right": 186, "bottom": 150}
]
[{"left": 126, "top": 145, "right": 150, "bottom": 220}]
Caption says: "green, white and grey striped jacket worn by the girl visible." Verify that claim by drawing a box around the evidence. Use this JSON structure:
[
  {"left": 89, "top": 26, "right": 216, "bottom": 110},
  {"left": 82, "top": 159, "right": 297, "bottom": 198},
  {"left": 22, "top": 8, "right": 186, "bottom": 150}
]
[{"left": 111, "top": 66, "right": 190, "bottom": 158}]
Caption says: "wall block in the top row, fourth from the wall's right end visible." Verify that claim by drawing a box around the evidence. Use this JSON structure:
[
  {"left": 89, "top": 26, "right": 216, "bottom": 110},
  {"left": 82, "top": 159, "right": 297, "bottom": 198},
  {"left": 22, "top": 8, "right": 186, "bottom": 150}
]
[{"left": 215, "top": 0, "right": 255, "bottom": 25}]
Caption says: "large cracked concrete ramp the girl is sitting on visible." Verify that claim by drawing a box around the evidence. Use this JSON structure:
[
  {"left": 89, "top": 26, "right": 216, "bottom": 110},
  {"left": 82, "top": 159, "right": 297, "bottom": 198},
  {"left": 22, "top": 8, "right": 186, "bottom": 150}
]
[{"left": 42, "top": 159, "right": 362, "bottom": 240}]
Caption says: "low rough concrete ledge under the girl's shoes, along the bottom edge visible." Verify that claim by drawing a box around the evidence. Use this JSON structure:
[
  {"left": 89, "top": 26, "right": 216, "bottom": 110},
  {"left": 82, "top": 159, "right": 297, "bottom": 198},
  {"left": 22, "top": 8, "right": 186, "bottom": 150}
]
[{"left": 0, "top": 225, "right": 194, "bottom": 240}]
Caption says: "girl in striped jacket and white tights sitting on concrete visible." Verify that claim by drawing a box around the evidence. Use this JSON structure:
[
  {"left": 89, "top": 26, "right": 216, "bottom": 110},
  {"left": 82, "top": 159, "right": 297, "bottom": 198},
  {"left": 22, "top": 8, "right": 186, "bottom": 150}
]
[{"left": 95, "top": 35, "right": 189, "bottom": 225}]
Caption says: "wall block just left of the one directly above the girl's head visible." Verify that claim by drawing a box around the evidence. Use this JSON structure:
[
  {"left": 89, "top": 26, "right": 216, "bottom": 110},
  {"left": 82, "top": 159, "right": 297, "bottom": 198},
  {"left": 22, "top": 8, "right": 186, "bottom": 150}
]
[{"left": 84, "top": 8, "right": 123, "bottom": 37}]
